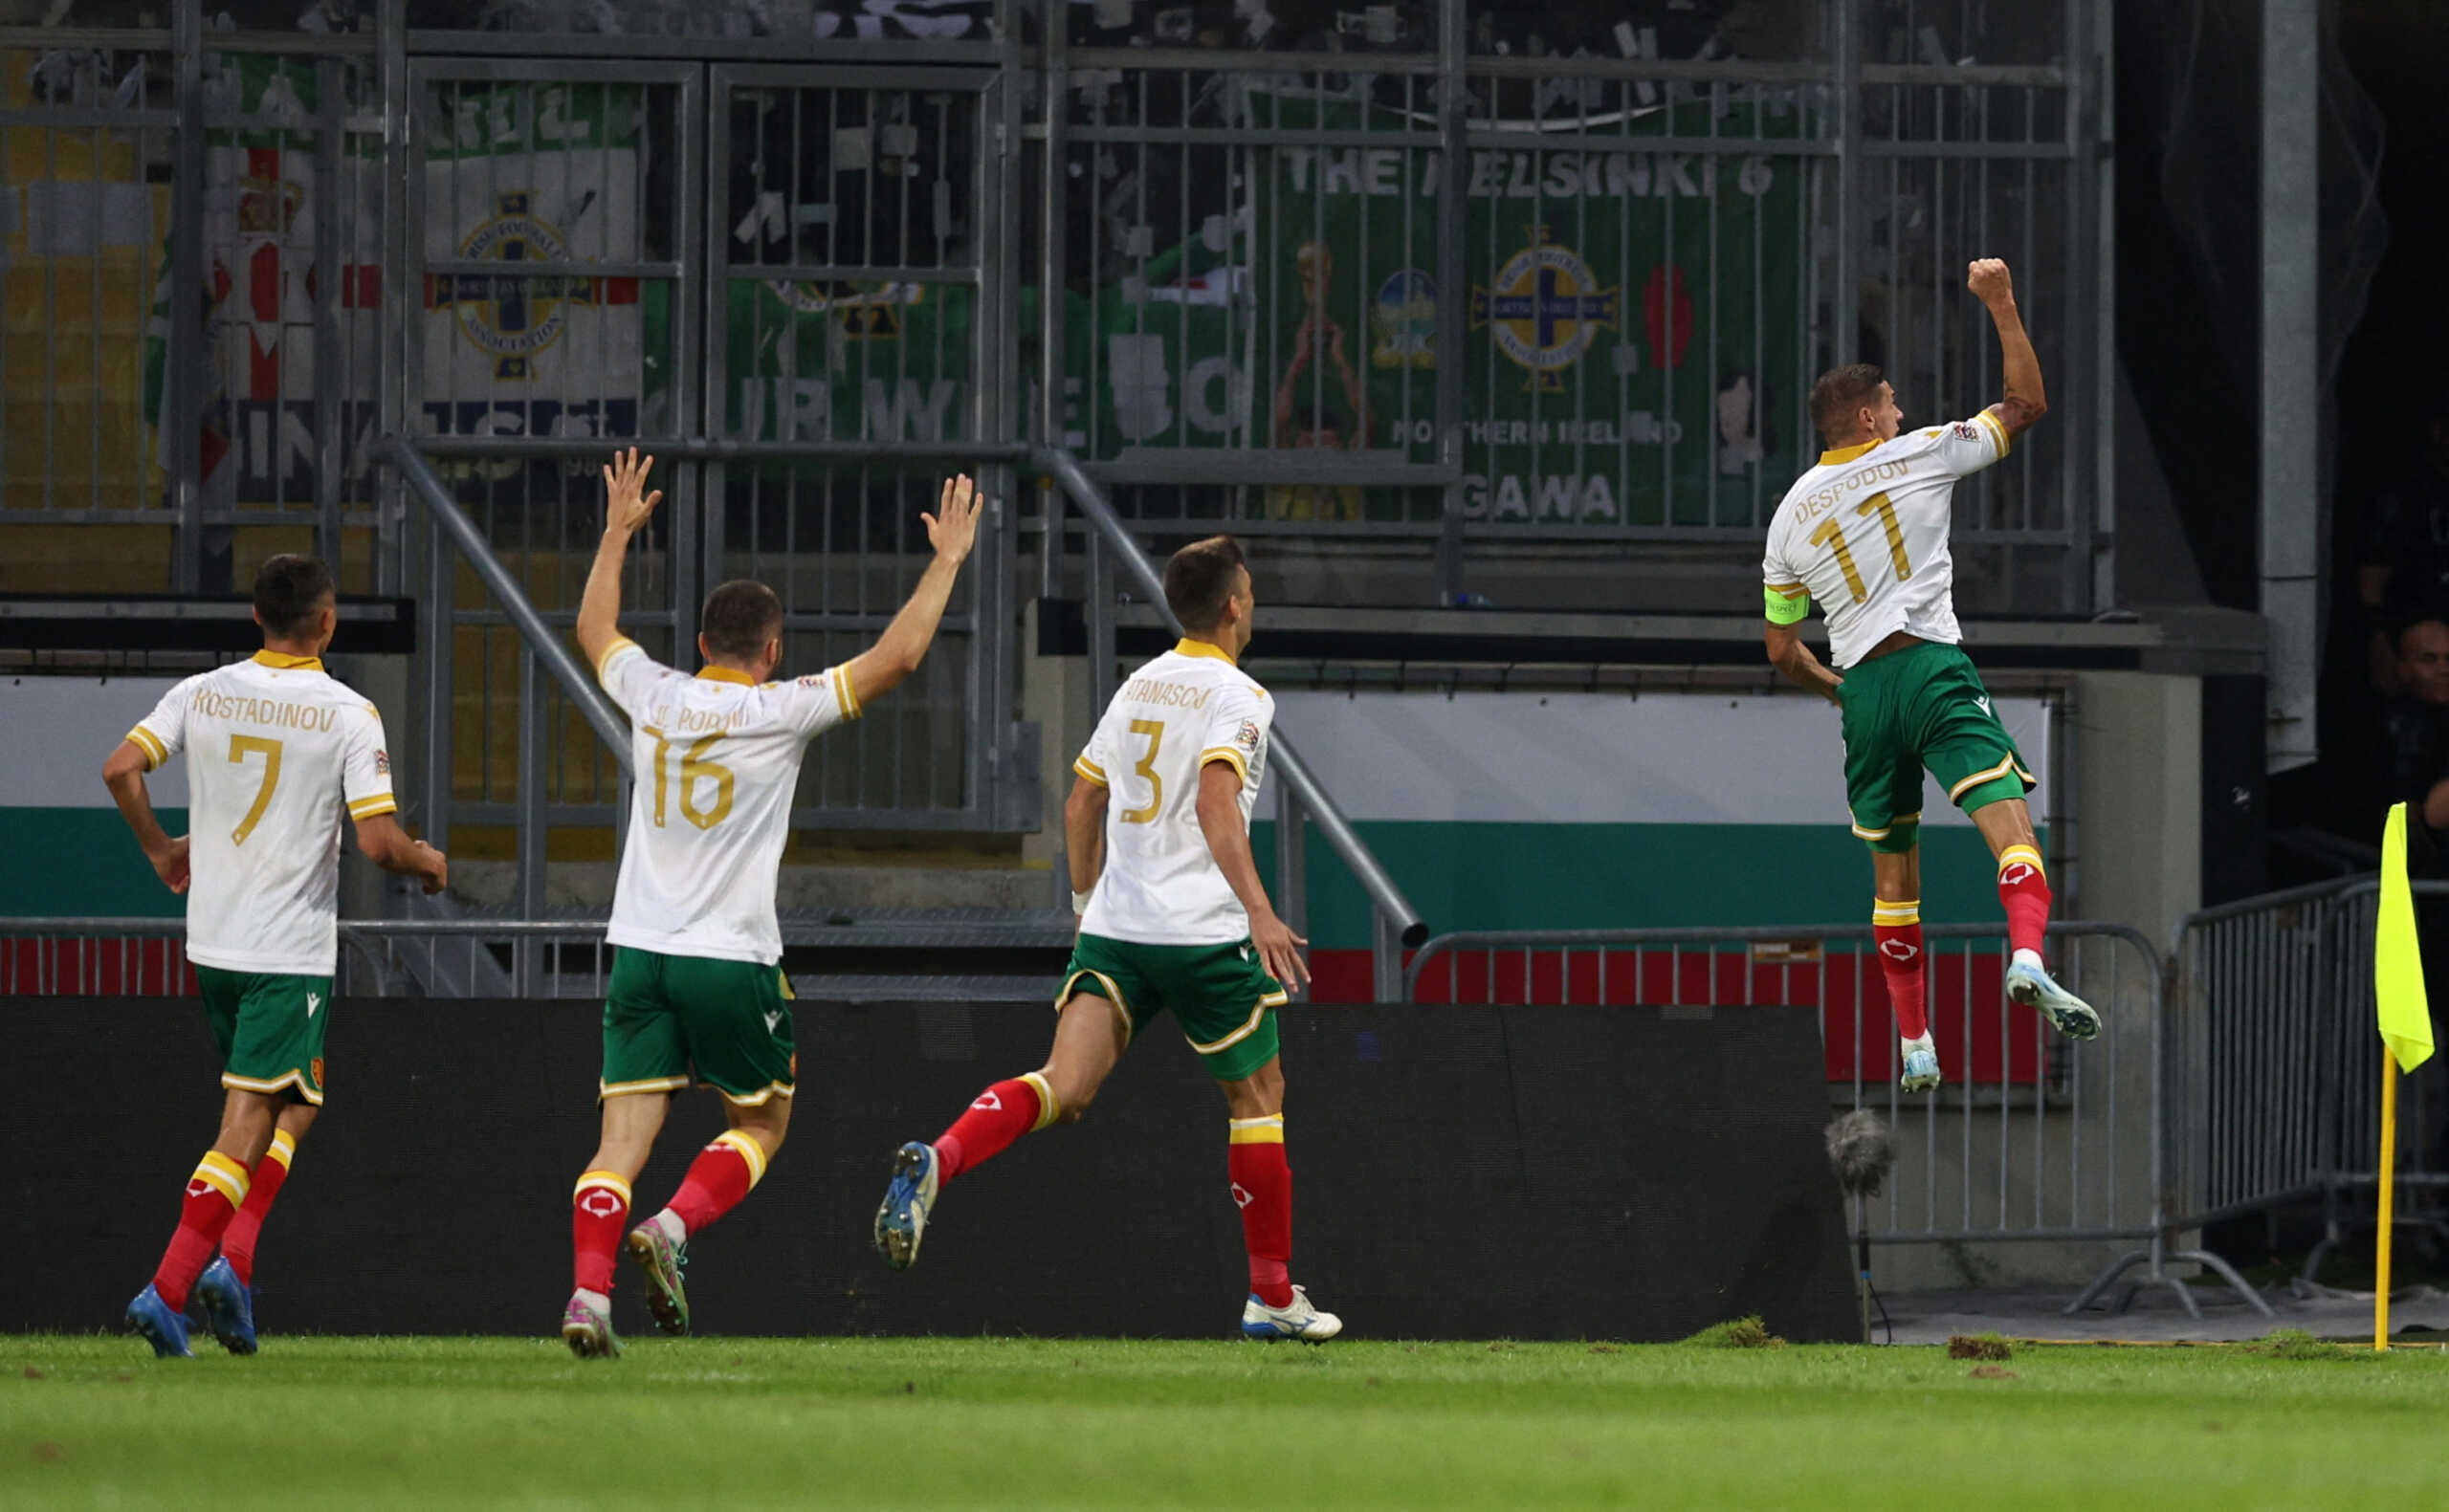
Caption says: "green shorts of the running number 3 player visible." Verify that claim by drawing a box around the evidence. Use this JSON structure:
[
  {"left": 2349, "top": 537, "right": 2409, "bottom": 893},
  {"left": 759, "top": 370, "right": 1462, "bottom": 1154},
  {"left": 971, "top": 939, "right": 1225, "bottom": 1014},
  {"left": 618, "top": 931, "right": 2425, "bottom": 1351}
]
[{"left": 1055, "top": 934, "right": 1286, "bottom": 1082}]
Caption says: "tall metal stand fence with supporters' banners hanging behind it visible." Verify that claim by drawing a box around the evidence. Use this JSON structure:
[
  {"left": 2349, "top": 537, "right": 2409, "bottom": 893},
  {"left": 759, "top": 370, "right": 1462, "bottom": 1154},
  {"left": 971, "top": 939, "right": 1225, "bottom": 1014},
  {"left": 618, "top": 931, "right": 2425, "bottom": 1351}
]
[{"left": 0, "top": 0, "right": 2111, "bottom": 829}]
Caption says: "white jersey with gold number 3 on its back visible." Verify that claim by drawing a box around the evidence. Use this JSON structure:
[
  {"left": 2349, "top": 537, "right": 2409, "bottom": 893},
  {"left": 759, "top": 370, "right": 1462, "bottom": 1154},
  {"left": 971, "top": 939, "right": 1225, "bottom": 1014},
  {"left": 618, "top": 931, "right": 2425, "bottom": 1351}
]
[{"left": 1072, "top": 641, "right": 1276, "bottom": 944}]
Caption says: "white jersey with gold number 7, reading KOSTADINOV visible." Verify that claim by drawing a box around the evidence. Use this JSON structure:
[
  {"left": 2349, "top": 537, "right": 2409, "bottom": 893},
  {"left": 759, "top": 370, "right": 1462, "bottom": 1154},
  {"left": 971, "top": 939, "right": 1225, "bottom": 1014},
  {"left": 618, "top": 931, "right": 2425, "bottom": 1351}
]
[{"left": 127, "top": 650, "right": 399, "bottom": 976}]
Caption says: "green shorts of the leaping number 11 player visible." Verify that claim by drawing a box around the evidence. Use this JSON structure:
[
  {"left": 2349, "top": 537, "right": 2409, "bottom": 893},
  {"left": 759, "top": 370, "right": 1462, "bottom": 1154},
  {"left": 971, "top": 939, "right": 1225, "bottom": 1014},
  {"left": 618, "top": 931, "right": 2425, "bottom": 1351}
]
[{"left": 1837, "top": 641, "right": 2038, "bottom": 851}]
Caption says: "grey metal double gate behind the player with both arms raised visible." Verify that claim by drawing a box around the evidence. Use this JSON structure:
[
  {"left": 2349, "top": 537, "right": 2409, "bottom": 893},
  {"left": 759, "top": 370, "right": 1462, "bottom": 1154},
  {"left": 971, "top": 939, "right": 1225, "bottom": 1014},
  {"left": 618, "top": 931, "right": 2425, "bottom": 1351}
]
[{"left": 404, "top": 58, "right": 1036, "bottom": 829}]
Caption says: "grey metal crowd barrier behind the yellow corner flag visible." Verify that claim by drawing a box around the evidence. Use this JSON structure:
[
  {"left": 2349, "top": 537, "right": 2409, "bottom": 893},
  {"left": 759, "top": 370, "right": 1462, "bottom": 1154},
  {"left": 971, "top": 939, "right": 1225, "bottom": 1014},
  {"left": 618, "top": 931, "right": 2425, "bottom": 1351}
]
[{"left": 2170, "top": 876, "right": 2449, "bottom": 1280}]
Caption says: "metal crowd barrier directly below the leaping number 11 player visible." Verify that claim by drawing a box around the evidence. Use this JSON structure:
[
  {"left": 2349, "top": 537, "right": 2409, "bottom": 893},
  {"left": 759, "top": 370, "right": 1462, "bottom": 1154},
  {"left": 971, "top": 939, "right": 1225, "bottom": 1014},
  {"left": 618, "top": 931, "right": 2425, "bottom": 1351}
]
[{"left": 1403, "top": 922, "right": 2261, "bottom": 1316}]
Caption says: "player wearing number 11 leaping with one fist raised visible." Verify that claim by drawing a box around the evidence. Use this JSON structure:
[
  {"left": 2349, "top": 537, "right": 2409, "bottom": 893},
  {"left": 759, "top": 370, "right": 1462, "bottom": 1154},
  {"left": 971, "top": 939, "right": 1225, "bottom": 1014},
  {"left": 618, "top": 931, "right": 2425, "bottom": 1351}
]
[{"left": 1761, "top": 257, "right": 2101, "bottom": 1091}]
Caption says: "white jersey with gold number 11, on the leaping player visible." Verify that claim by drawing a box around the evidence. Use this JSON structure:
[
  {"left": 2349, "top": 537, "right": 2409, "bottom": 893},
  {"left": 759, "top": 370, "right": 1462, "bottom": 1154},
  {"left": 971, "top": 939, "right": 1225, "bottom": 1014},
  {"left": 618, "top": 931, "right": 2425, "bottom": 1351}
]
[{"left": 1761, "top": 408, "right": 2008, "bottom": 670}]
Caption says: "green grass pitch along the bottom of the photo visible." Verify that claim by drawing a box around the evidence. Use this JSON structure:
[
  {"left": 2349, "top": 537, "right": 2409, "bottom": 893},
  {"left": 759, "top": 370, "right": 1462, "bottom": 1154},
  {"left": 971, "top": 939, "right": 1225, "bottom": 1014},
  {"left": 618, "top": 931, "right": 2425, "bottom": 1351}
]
[{"left": 0, "top": 1336, "right": 2449, "bottom": 1512}]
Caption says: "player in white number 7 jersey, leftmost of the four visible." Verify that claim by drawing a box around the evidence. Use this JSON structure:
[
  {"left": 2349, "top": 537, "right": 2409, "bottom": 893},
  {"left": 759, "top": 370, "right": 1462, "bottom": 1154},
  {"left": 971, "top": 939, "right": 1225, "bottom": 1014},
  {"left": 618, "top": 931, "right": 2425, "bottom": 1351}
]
[{"left": 103, "top": 556, "right": 448, "bottom": 1355}]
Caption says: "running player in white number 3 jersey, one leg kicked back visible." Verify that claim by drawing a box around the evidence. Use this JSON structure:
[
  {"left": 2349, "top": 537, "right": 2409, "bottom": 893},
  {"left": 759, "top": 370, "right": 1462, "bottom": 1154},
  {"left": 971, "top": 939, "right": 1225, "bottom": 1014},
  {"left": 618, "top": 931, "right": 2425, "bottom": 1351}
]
[{"left": 876, "top": 536, "right": 1342, "bottom": 1341}]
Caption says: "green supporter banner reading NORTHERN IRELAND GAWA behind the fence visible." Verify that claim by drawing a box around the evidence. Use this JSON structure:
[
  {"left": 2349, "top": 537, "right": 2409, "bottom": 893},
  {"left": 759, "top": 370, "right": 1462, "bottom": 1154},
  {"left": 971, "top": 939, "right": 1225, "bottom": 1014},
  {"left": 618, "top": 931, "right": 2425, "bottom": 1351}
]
[{"left": 1066, "top": 96, "right": 1807, "bottom": 523}]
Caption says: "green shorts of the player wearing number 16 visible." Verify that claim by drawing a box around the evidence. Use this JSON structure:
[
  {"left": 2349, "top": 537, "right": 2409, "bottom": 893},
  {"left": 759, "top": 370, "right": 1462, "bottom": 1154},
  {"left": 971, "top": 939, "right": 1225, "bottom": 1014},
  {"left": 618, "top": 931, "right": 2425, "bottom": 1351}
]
[{"left": 595, "top": 944, "right": 799, "bottom": 1108}]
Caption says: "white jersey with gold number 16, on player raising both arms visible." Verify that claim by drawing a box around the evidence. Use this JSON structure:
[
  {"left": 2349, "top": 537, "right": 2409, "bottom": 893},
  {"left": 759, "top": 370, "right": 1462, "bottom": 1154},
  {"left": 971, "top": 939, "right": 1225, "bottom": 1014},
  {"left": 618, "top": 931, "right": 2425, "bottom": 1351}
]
[{"left": 595, "top": 639, "right": 860, "bottom": 967}]
